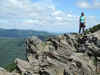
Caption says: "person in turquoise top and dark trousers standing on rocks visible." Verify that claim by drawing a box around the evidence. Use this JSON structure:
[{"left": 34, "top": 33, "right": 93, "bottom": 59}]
[{"left": 79, "top": 12, "right": 86, "bottom": 33}]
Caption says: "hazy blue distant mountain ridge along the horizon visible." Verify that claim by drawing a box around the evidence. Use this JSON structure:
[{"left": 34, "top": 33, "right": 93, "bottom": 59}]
[{"left": 0, "top": 28, "right": 54, "bottom": 38}]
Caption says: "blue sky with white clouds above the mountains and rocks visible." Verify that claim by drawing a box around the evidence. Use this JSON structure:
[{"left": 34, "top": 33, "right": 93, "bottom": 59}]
[{"left": 0, "top": 0, "right": 100, "bottom": 32}]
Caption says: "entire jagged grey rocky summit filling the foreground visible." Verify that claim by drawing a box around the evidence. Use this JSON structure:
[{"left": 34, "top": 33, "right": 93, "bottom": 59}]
[{"left": 0, "top": 31, "right": 100, "bottom": 75}]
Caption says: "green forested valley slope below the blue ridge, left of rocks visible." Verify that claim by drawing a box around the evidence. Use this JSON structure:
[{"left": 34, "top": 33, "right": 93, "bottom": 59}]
[{"left": 0, "top": 38, "right": 25, "bottom": 67}]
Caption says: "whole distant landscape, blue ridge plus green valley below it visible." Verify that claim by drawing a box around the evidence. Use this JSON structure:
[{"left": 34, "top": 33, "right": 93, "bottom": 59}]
[{"left": 0, "top": 28, "right": 54, "bottom": 67}]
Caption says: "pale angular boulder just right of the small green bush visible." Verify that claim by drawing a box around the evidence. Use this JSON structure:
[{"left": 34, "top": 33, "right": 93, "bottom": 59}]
[{"left": 15, "top": 58, "right": 39, "bottom": 75}]
